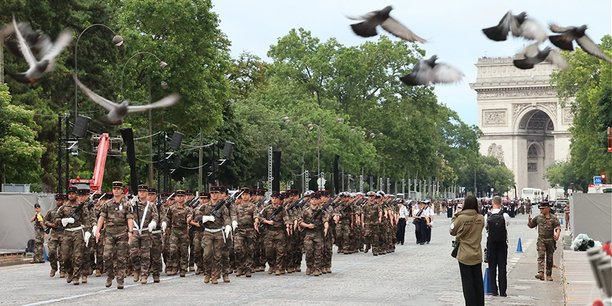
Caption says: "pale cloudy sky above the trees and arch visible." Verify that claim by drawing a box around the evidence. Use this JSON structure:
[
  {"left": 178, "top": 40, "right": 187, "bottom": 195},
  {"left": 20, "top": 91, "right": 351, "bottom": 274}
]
[{"left": 213, "top": 0, "right": 612, "bottom": 124}]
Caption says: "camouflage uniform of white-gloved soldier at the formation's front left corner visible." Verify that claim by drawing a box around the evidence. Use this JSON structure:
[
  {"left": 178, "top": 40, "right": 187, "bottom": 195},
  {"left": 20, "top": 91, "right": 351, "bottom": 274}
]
[{"left": 55, "top": 200, "right": 90, "bottom": 285}]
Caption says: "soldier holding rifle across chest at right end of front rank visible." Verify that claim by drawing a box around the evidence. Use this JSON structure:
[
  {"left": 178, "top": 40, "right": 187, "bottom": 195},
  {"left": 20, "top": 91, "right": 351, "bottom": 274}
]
[{"left": 300, "top": 193, "right": 329, "bottom": 276}]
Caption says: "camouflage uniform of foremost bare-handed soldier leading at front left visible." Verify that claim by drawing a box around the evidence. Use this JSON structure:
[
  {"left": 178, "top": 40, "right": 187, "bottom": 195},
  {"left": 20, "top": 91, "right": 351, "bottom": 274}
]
[{"left": 100, "top": 197, "right": 134, "bottom": 287}]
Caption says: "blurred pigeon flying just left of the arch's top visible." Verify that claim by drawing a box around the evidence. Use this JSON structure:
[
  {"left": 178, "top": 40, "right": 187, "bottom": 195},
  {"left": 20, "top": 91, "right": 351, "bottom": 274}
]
[{"left": 400, "top": 55, "right": 464, "bottom": 86}]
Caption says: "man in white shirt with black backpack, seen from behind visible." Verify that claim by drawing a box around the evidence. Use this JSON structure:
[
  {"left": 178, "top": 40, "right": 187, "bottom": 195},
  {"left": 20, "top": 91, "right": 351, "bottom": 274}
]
[{"left": 485, "top": 196, "right": 510, "bottom": 296}]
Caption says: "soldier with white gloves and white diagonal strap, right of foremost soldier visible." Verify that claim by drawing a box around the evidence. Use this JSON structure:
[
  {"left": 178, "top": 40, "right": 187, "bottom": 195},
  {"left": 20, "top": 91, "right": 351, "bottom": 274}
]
[{"left": 130, "top": 185, "right": 158, "bottom": 285}]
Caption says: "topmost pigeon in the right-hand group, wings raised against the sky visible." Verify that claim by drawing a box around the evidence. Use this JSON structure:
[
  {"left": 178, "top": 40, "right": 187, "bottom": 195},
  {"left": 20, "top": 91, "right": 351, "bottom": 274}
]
[{"left": 482, "top": 11, "right": 548, "bottom": 42}]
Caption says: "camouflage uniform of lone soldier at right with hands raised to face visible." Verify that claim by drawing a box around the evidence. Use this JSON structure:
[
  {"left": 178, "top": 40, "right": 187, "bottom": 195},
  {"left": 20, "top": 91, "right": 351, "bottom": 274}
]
[{"left": 529, "top": 213, "right": 561, "bottom": 276}]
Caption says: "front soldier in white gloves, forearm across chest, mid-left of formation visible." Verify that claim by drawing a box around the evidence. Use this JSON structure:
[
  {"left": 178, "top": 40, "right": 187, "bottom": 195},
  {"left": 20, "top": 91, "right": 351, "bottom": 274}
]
[{"left": 197, "top": 186, "right": 232, "bottom": 284}]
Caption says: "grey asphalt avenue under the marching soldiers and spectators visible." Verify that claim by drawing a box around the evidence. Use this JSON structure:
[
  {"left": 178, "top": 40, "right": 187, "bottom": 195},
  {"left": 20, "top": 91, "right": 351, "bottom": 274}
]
[{"left": 0, "top": 215, "right": 563, "bottom": 305}]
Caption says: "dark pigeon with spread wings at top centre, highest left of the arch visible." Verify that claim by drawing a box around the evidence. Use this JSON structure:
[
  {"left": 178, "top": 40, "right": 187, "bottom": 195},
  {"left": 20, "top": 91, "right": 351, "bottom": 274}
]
[{"left": 347, "top": 5, "right": 427, "bottom": 43}]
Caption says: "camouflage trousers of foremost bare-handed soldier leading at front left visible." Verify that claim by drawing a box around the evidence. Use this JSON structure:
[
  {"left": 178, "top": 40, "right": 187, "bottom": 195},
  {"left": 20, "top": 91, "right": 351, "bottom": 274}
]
[{"left": 103, "top": 231, "right": 129, "bottom": 282}]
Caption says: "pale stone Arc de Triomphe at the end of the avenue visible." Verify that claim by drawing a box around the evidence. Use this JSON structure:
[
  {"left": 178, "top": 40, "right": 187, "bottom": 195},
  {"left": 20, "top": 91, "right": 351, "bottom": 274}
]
[{"left": 470, "top": 57, "right": 572, "bottom": 197}]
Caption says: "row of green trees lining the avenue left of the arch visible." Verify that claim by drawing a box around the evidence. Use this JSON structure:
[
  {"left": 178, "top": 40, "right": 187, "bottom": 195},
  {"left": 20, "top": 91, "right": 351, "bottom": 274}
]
[{"left": 0, "top": 0, "right": 513, "bottom": 192}]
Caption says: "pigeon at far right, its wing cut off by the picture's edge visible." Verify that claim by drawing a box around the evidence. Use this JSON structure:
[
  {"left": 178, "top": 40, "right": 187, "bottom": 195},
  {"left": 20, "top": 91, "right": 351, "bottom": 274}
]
[{"left": 548, "top": 23, "right": 612, "bottom": 63}]
